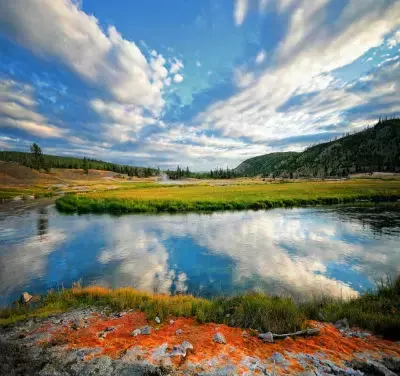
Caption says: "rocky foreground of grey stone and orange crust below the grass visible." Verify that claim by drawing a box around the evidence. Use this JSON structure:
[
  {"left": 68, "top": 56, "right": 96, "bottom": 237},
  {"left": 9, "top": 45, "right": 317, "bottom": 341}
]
[{"left": 0, "top": 309, "right": 400, "bottom": 376}]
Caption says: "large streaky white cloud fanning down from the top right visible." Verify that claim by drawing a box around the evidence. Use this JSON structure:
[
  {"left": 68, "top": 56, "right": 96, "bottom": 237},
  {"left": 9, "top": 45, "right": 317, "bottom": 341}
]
[{"left": 199, "top": 0, "right": 400, "bottom": 142}]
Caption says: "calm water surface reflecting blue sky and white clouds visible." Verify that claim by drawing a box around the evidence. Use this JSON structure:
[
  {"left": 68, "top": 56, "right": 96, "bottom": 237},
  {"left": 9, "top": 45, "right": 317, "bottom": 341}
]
[{"left": 0, "top": 205, "right": 400, "bottom": 305}]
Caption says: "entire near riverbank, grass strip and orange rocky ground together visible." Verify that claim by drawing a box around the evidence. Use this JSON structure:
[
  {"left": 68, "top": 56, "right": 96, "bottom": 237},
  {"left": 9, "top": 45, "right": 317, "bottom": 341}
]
[{"left": 0, "top": 282, "right": 400, "bottom": 376}]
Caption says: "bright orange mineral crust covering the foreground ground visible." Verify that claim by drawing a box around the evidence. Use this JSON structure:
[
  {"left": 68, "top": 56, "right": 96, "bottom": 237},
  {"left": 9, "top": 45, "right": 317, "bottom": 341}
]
[{"left": 38, "top": 312, "right": 400, "bottom": 374}]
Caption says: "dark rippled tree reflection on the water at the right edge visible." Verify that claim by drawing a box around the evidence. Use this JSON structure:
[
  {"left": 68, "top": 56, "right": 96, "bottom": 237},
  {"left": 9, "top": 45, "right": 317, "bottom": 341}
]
[{"left": 336, "top": 204, "right": 400, "bottom": 234}]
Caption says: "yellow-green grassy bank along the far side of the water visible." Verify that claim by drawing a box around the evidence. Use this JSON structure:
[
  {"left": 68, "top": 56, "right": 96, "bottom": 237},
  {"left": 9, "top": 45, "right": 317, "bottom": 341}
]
[{"left": 56, "top": 180, "right": 400, "bottom": 214}]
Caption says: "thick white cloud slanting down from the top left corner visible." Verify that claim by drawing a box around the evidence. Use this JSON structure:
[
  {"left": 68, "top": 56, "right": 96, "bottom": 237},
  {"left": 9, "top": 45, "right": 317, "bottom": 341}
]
[{"left": 0, "top": 0, "right": 172, "bottom": 114}]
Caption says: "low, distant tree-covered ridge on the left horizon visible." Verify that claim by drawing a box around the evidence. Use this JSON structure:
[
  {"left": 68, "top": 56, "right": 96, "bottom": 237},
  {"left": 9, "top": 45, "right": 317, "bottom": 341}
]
[{"left": 0, "top": 151, "right": 159, "bottom": 177}]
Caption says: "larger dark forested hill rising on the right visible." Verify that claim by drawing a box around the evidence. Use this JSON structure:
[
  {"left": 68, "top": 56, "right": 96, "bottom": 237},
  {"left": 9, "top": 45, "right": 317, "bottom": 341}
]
[{"left": 234, "top": 119, "right": 400, "bottom": 178}]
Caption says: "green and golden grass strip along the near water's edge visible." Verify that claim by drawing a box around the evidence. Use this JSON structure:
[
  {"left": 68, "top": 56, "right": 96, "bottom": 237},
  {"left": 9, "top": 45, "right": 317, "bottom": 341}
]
[{"left": 0, "top": 278, "right": 400, "bottom": 339}]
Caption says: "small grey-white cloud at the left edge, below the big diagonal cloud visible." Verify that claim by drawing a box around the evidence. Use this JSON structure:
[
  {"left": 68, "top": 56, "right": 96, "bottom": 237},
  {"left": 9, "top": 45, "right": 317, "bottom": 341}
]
[{"left": 0, "top": 80, "right": 65, "bottom": 137}]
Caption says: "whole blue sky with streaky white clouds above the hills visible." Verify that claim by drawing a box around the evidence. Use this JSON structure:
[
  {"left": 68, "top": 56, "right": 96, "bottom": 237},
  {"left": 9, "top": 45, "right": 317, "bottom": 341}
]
[{"left": 0, "top": 0, "right": 400, "bottom": 171}]
